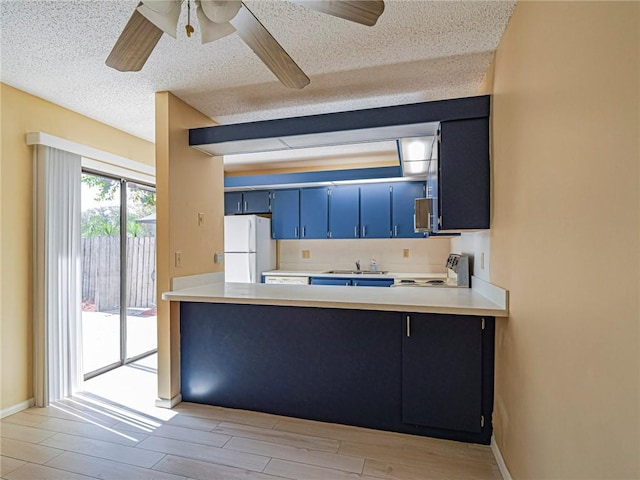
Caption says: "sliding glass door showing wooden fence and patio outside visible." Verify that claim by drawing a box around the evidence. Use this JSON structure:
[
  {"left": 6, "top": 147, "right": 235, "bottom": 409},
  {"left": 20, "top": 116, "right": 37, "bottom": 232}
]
[{"left": 82, "top": 172, "right": 156, "bottom": 378}]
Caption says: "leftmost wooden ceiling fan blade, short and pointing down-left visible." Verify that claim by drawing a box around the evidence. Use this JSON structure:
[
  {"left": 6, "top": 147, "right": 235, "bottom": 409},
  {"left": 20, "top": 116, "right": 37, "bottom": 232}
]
[{"left": 105, "top": 10, "right": 162, "bottom": 72}]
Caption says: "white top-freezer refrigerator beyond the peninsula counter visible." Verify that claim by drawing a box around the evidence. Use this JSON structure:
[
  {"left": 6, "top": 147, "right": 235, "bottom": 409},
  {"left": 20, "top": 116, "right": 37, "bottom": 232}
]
[{"left": 224, "top": 215, "right": 276, "bottom": 283}]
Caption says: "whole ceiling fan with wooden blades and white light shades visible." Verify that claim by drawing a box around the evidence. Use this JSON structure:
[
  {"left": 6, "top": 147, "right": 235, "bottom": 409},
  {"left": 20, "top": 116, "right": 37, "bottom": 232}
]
[{"left": 106, "top": 0, "right": 384, "bottom": 88}]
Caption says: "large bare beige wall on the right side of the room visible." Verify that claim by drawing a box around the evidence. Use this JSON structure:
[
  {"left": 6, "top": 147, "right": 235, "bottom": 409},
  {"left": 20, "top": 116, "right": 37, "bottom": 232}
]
[{"left": 491, "top": 2, "right": 640, "bottom": 479}]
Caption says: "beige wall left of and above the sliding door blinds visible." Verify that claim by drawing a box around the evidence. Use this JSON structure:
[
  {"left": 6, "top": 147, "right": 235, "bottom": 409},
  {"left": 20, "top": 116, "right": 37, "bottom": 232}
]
[{"left": 0, "top": 84, "right": 154, "bottom": 409}]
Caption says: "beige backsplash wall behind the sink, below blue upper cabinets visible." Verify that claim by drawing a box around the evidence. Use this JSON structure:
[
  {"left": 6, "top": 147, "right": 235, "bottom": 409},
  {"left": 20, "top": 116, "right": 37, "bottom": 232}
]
[{"left": 278, "top": 238, "right": 451, "bottom": 273}]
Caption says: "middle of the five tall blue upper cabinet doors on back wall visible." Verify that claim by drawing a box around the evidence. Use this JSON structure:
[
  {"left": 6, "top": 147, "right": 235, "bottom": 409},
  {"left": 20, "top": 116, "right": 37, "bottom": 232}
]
[{"left": 329, "top": 185, "right": 360, "bottom": 238}]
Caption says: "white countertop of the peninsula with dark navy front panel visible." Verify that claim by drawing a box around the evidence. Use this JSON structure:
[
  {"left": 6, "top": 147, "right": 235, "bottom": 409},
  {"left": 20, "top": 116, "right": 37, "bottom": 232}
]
[{"left": 162, "top": 275, "right": 508, "bottom": 317}]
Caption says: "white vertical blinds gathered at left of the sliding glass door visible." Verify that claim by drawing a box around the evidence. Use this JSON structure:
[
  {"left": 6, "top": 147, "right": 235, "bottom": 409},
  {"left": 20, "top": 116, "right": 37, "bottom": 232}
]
[{"left": 34, "top": 145, "right": 83, "bottom": 407}]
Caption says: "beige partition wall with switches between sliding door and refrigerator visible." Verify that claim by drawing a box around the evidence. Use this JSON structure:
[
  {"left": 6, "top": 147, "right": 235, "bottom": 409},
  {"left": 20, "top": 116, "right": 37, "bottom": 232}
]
[{"left": 156, "top": 92, "right": 224, "bottom": 400}]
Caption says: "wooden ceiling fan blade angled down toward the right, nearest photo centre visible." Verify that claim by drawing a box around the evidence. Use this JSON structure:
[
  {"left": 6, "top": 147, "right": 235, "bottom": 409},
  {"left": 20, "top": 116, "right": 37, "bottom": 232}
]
[{"left": 230, "top": 3, "right": 310, "bottom": 88}]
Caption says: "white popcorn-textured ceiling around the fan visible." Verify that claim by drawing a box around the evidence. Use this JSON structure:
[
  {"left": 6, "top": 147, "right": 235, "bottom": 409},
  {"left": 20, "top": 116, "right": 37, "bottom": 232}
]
[{"left": 0, "top": 0, "right": 515, "bottom": 141}]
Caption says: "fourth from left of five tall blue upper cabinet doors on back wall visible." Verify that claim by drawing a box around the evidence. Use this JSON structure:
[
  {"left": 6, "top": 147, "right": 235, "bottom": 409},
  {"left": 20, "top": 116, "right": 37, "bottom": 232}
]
[{"left": 360, "top": 183, "right": 391, "bottom": 238}]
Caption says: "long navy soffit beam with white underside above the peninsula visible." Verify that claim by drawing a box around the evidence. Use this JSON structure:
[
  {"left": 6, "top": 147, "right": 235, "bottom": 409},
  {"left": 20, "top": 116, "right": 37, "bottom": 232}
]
[{"left": 189, "top": 95, "right": 490, "bottom": 155}]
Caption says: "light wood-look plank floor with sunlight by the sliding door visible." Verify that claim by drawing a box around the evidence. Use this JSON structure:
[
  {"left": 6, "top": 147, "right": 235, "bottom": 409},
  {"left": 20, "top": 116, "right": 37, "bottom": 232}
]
[{"left": 0, "top": 359, "right": 502, "bottom": 480}]
